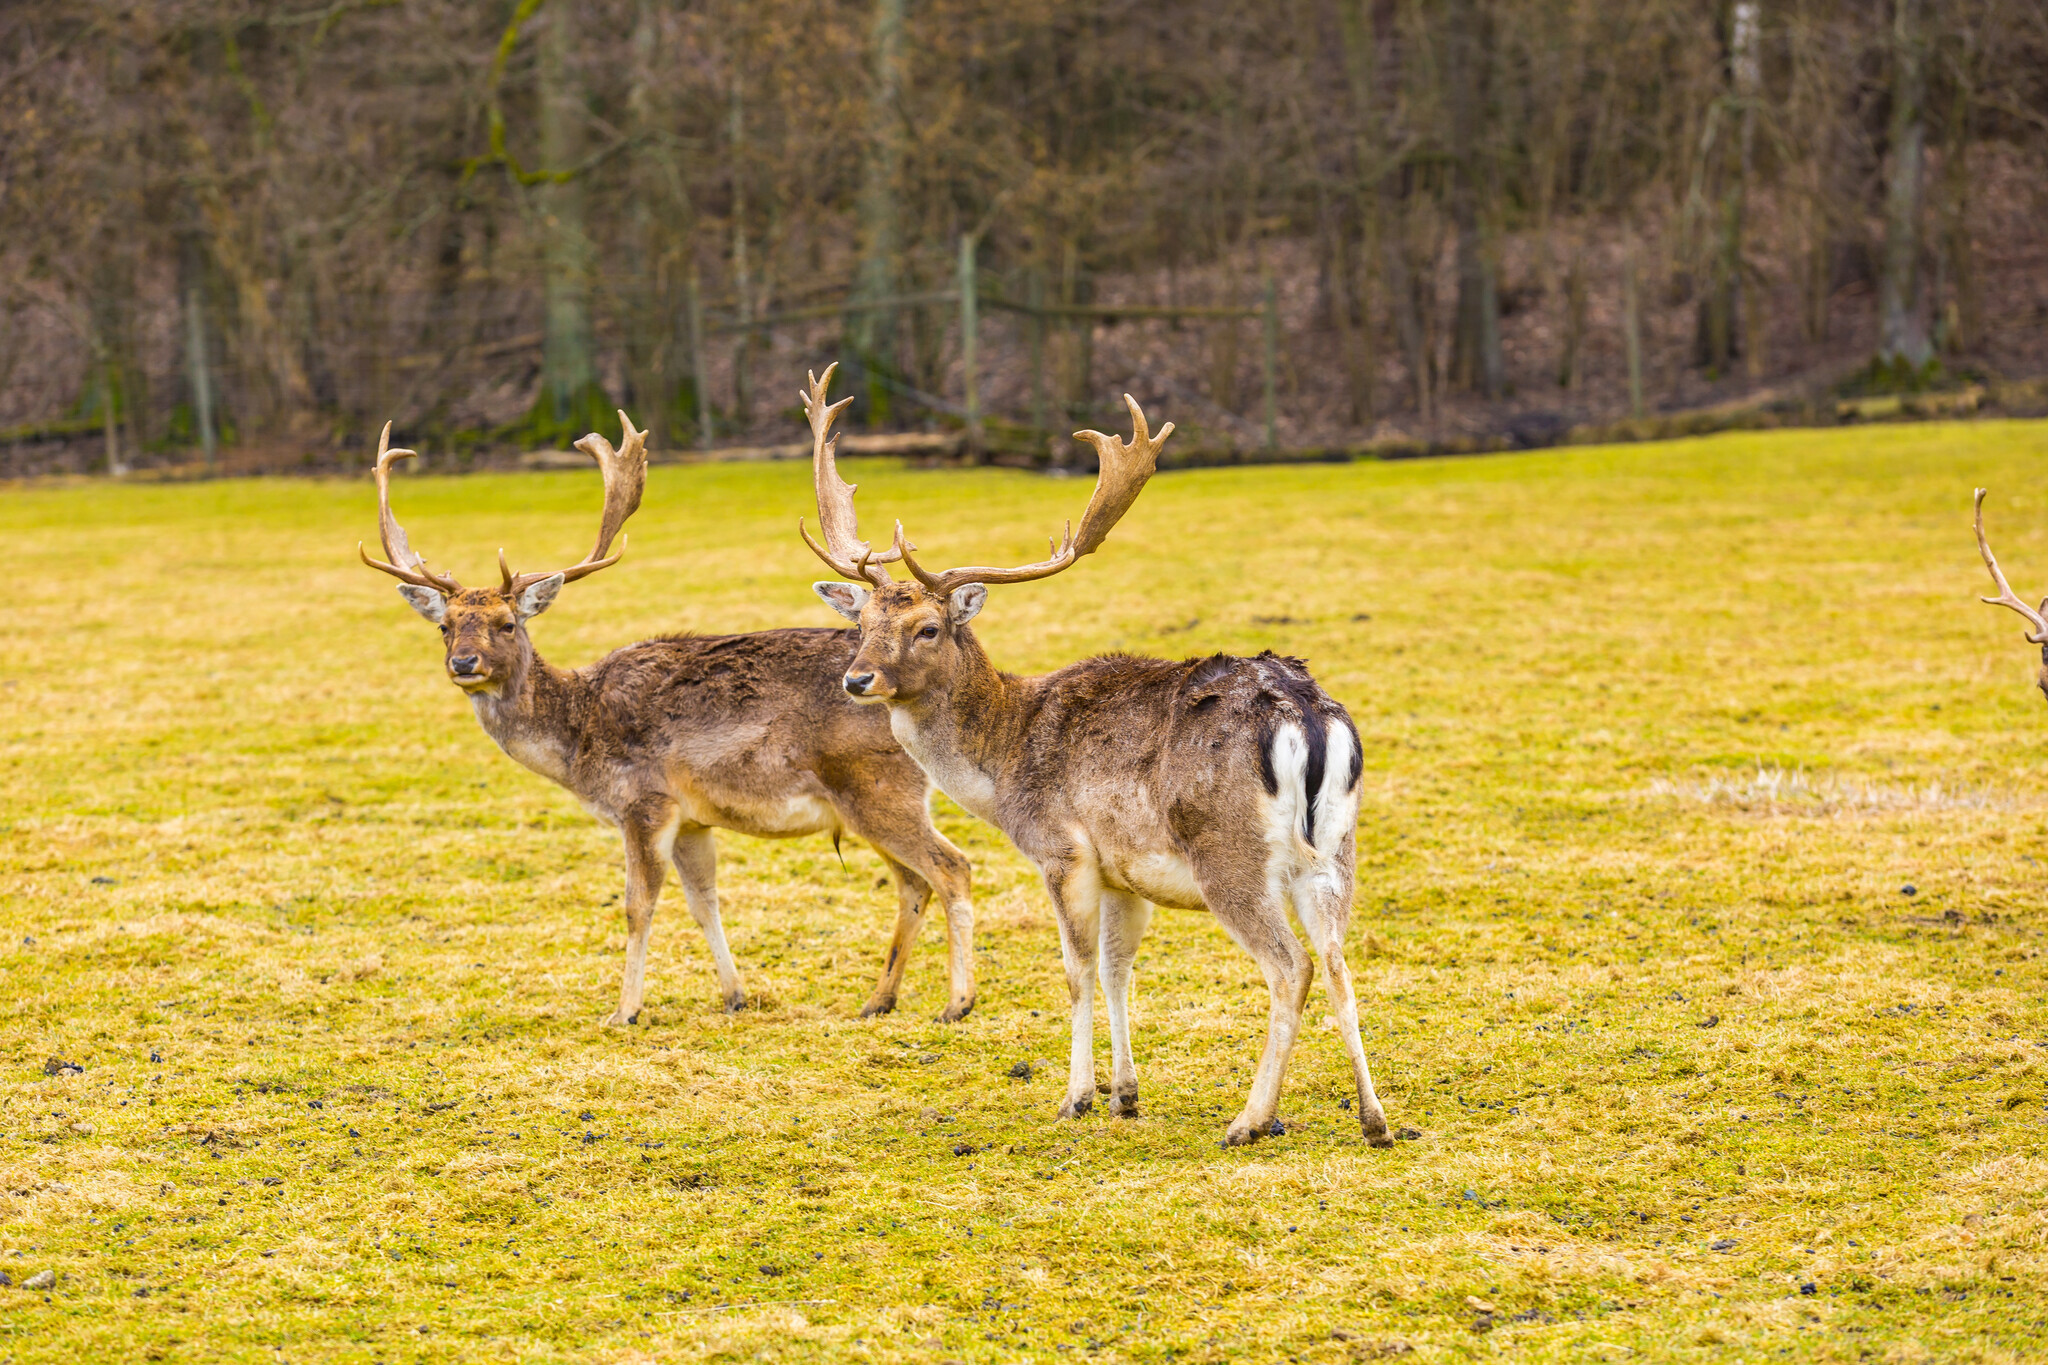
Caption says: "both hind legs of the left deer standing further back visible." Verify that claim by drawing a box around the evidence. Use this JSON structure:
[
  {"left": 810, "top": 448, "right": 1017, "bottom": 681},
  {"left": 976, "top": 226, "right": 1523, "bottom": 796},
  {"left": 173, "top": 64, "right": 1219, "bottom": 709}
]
[{"left": 834, "top": 777, "right": 975, "bottom": 1023}]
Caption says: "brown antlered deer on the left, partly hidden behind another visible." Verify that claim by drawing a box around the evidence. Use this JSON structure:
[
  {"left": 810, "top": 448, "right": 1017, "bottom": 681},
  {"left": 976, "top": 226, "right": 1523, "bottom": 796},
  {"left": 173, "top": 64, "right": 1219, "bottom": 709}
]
[{"left": 356, "top": 411, "right": 975, "bottom": 1025}]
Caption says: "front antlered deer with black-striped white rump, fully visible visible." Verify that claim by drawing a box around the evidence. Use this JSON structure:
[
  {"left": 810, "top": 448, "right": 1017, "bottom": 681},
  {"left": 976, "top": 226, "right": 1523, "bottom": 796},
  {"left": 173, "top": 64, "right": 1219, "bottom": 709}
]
[{"left": 797, "top": 366, "right": 1393, "bottom": 1146}]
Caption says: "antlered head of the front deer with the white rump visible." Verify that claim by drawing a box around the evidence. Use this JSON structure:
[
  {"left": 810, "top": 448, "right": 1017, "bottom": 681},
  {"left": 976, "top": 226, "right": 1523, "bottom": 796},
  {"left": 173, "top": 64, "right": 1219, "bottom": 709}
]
[{"left": 797, "top": 366, "right": 1174, "bottom": 702}]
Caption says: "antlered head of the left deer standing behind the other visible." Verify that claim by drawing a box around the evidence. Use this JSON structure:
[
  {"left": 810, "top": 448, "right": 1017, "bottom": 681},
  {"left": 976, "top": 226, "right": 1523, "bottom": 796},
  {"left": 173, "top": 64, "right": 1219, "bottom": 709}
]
[{"left": 356, "top": 411, "right": 647, "bottom": 694}]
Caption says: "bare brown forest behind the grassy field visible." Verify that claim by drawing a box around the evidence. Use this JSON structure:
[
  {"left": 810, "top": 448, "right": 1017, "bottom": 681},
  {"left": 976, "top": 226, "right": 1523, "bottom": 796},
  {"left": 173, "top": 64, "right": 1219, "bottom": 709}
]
[{"left": 0, "top": 0, "right": 2048, "bottom": 473}]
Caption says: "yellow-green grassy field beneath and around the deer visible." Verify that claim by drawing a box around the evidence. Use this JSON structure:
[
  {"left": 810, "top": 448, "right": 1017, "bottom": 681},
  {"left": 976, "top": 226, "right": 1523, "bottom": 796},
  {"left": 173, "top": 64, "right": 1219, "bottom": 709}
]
[{"left": 0, "top": 424, "right": 2048, "bottom": 1361}]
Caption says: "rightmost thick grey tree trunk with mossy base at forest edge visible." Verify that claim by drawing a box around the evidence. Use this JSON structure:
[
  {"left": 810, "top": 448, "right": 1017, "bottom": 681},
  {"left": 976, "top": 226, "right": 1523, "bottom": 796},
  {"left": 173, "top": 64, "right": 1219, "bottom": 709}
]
[{"left": 1878, "top": 0, "right": 1933, "bottom": 377}]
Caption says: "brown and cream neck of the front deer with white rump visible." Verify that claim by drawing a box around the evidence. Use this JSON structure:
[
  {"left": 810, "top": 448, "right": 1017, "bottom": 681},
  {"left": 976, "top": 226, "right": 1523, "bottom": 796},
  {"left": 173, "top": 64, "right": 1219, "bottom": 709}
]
[{"left": 889, "top": 626, "right": 1024, "bottom": 825}]
